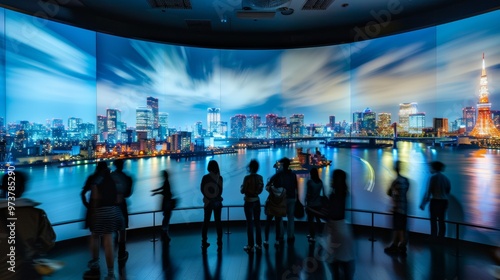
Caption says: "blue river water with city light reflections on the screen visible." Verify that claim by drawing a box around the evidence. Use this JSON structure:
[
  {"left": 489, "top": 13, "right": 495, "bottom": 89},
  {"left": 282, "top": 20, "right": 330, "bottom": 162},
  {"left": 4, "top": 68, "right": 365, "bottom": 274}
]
[{"left": 11, "top": 142, "right": 500, "bottom": 244}]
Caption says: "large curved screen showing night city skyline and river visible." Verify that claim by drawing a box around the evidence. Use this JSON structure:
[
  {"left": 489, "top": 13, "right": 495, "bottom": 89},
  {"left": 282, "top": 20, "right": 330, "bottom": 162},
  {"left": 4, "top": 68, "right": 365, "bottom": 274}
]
[{"left": 0, "top": 9, "right": 500, "bottom": 245}]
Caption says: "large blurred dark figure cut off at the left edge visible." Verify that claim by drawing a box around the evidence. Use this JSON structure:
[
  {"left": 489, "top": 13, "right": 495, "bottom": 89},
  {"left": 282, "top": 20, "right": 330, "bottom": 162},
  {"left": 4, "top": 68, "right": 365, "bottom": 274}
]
[{"left": 0, "top": 171, "right": 56, "bottom": 280}]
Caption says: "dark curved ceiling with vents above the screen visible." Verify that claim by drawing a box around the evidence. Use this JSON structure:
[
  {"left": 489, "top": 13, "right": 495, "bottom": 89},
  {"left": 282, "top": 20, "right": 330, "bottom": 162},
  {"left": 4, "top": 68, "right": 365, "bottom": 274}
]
[{"left": 0, "top": 0, "right": 500, "bottom": 49}]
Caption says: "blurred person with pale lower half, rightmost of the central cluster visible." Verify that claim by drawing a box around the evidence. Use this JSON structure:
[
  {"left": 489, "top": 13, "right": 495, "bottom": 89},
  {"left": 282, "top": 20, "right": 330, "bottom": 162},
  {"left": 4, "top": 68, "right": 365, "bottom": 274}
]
[{"left": 326, "top": 169, "right": 355, "bottom": 279}]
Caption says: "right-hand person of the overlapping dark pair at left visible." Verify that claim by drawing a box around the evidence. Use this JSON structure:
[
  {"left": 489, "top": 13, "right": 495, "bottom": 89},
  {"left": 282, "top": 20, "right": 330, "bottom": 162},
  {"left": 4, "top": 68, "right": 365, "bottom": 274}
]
[{"left": 111, "top": 159, "right": 132, "bottom": 262}]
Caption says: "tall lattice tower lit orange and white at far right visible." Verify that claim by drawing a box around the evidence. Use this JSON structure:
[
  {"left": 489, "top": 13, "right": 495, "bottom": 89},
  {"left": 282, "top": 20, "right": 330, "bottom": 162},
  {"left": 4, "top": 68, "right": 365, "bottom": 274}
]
[{"left": 469, "top": 53, "right": 500, "bottom": 138}]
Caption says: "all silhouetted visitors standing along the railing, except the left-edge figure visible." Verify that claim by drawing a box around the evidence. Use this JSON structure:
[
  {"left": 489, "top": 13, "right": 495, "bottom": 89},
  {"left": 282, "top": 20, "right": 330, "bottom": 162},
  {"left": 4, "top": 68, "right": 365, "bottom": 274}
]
[{"left": 75, "top": 157, "right": 451, "bottom": 279}]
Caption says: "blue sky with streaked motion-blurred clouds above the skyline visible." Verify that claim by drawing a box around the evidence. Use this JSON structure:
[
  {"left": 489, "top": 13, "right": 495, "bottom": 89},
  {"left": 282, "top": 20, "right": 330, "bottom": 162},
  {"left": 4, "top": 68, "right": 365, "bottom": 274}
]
[{"left": 0, "top": 10, "right": 500, "bottom": 129}]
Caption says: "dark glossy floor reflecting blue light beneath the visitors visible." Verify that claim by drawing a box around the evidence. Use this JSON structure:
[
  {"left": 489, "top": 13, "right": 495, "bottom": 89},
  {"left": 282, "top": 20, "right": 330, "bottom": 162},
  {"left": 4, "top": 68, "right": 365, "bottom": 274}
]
[{"left": 46, "top": 223, "right": 495, "bottom": 280}]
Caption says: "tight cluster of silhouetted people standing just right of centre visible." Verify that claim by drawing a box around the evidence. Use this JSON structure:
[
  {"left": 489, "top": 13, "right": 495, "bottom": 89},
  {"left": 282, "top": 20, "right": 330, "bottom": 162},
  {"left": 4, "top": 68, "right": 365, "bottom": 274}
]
[{"left": 234, "top": 158, "right": 354, "bottom": 279}]
